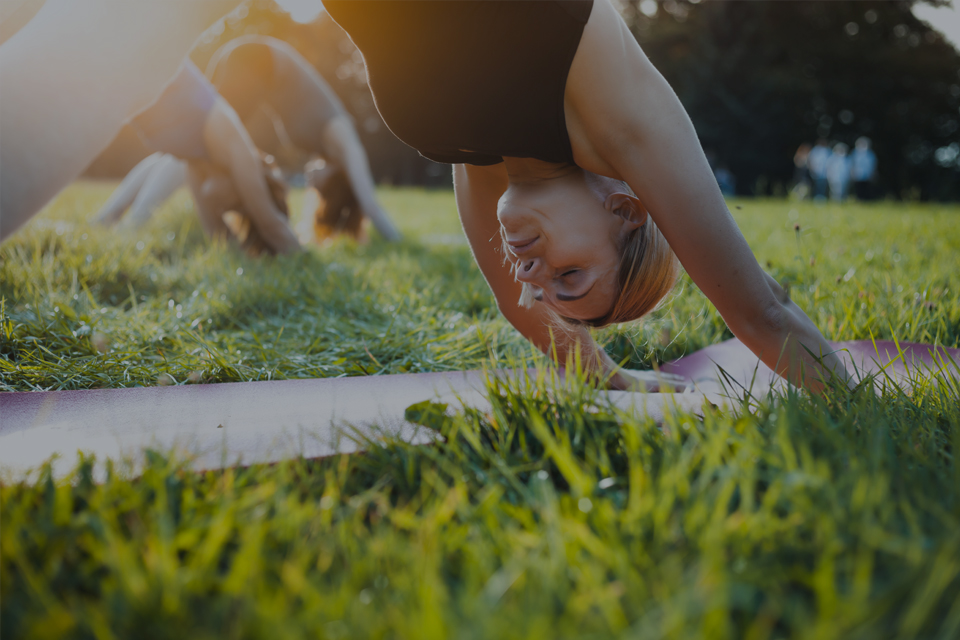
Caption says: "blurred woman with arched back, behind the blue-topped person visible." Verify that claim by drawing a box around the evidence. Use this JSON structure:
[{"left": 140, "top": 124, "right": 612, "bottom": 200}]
[{"left": 207, "top": 36, "right": 400, "bottom": 240}]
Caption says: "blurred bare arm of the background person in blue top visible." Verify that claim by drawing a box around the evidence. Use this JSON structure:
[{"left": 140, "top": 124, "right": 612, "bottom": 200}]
[{"left": 203, "top": 98, "right": 300, "bottom": 253}]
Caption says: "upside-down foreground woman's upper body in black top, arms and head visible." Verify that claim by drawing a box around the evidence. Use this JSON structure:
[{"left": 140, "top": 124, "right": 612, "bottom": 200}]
[{"left": 324, "top": 0, "right": 847, "bottom": 391}]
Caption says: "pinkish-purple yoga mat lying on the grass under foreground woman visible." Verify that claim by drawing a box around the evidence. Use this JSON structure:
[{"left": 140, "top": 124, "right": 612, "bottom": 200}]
[{"left": 0, "top": 340, "right": 960, "bottom": 476}]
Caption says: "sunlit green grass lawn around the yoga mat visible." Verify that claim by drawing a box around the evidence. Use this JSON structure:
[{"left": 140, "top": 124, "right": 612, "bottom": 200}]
[{"left": 0, "top": 184, "right": 960, "bottom": 638}]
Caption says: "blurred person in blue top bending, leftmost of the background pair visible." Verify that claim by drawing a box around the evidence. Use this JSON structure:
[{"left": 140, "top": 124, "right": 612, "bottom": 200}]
[{"left": 97, "top": 61, "right": 300, "bottom": 253}]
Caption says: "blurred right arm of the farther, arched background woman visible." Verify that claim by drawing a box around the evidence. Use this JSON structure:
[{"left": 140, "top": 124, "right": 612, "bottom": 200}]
[{"left": 324, "top": 116, "right": 400, "bottom": 241}]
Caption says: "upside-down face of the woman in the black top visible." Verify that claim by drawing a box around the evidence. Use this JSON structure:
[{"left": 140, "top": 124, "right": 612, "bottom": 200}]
[{"left": 497, "top": 171, "right": 646, "bottom": 320}]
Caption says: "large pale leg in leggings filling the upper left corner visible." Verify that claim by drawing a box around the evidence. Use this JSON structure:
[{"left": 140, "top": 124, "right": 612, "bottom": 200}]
[{"left": 0, "top": 0, "right": 240, "bottom": 240}]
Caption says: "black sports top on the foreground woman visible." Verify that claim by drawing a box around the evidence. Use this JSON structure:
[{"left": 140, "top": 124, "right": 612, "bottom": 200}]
[{"left": 323, "top": 0, "right": 593, "bottom": 165}]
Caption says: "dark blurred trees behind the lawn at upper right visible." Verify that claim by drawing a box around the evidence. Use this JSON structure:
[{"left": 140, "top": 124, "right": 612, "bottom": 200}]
[{"left": 623, "top": 0, "right": 960, "bottom": 199}]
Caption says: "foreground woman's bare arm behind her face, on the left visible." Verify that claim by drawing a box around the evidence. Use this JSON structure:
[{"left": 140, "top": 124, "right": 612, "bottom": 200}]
[{"left": 453, "top": 164, "right": 633, "bottom": 389}]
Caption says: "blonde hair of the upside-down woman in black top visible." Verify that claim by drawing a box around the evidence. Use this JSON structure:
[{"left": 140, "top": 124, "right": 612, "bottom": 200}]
[{"left": 520, "top": 216, "right": 680, "bottom": 327}]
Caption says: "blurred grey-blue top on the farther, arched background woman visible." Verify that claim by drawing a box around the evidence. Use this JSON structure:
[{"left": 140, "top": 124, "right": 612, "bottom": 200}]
[{"left": 207, "top": 35, "right": 346, "bottom": 155}]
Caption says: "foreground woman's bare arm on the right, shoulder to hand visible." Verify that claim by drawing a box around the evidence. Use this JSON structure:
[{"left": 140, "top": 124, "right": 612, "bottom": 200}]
[{"left": 566, "top": 0, "right": 848, "bottom": 392}]
